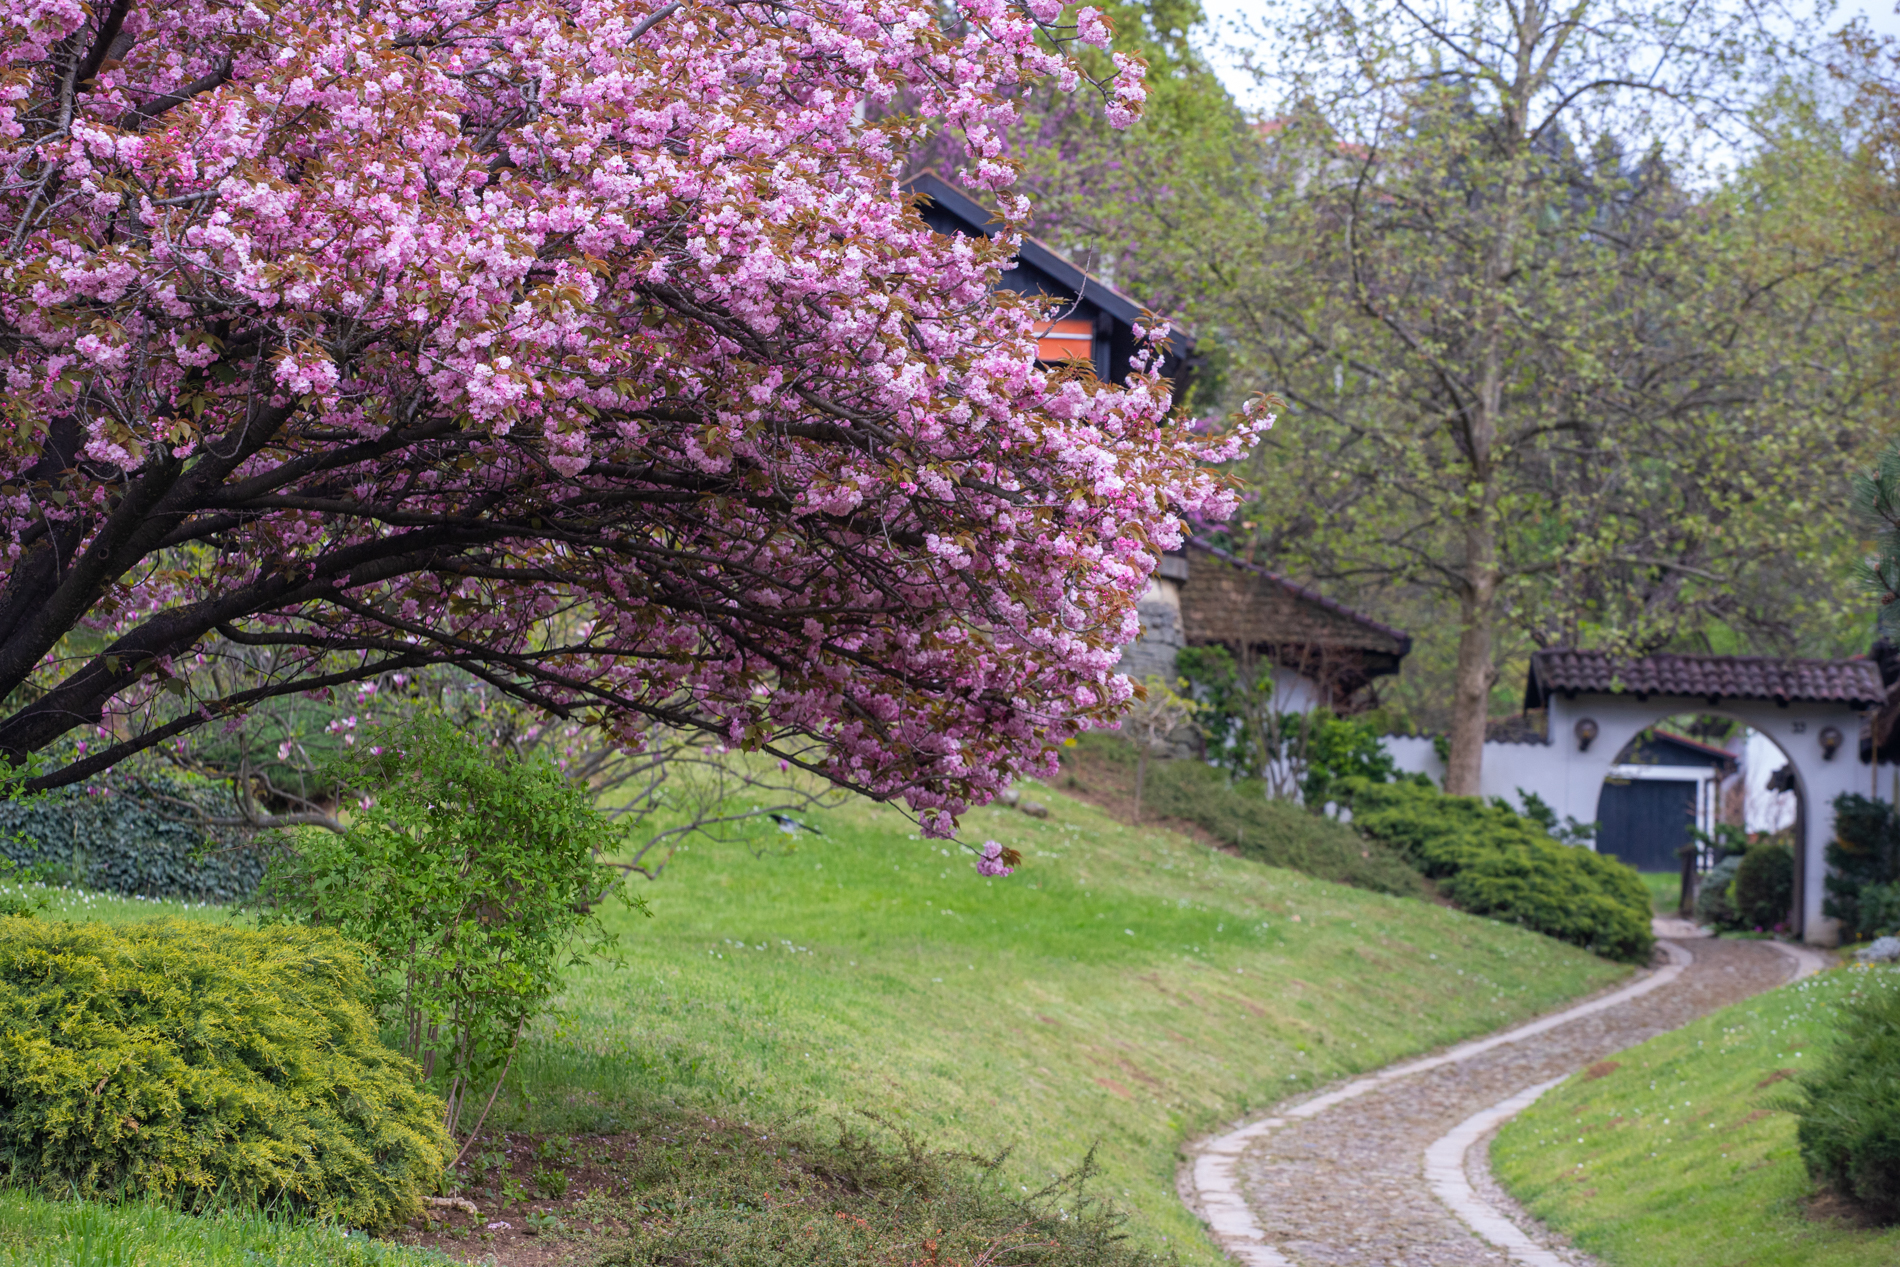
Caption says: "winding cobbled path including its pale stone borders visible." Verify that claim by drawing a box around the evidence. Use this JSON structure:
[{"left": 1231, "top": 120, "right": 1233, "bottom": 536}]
[{"left": 1182, "top": 921, "right": 1826, "bottom": 1267}]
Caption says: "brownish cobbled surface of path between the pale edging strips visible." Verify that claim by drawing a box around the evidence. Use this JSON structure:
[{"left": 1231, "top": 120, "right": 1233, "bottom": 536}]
[{"left": 1239, "top": 938, "right": 1796, "bottom": 1267}]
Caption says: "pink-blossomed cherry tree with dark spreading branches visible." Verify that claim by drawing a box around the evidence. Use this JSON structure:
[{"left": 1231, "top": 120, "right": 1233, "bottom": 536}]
[{"left": 0, "top": 0, "right": 1269, "bottom": 834}]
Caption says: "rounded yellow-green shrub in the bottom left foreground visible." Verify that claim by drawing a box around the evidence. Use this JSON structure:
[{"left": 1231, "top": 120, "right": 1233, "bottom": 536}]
[{"left": 0, "top": 919, "right": 448, "bottom": 1229}]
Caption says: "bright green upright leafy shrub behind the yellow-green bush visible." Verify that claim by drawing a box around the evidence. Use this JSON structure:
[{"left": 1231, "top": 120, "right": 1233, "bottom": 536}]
[{"left": 258, "top": 716, "right": 623, "bottom": 1130}]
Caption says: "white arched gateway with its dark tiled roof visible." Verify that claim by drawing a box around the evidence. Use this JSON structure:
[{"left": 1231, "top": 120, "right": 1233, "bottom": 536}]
[{"left": 1387, "top": 650, "right": 1887, "bottom": 946}]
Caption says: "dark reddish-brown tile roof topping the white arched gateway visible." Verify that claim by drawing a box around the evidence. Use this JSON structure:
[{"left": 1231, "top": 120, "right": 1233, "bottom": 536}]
[{"left": 1524, "top": 648, "right": 1887, "bottom": 709}]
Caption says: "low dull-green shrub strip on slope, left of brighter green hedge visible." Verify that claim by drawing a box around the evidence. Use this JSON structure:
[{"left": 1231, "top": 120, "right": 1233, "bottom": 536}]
[{"left": 1062, "top": 733, "right": 1425, "bottom": 897}]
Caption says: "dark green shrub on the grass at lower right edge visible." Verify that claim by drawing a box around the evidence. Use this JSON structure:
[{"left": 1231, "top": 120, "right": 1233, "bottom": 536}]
[{"left": 1796, "top": 973, "right": 1900, "bottom": 1223}]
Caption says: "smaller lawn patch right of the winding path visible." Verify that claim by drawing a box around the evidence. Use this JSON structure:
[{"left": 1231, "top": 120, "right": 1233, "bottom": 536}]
[{"left": 1492, "top": 969, "right": 1900, "bottom": 1267}]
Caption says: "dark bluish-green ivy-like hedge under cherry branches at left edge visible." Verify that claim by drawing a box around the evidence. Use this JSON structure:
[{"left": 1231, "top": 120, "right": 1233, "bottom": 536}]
[{"left": 0, "top": 775, "right": 274, "bottom": 902}]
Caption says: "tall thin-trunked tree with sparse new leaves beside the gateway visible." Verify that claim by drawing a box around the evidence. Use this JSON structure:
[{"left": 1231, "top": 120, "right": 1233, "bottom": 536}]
[{"left": 1238, "top": 69, "right": 1879, "bottom": 792}]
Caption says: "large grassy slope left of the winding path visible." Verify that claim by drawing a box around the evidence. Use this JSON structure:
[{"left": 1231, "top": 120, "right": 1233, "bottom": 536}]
[{"left": 505, "top": 788, "right": 1626, "bottom": 1263}]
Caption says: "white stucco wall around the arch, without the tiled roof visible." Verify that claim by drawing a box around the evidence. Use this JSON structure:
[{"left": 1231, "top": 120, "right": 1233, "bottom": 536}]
[{"left": 1385, "top": 695, "right": 1869, "bottom": 946}]
